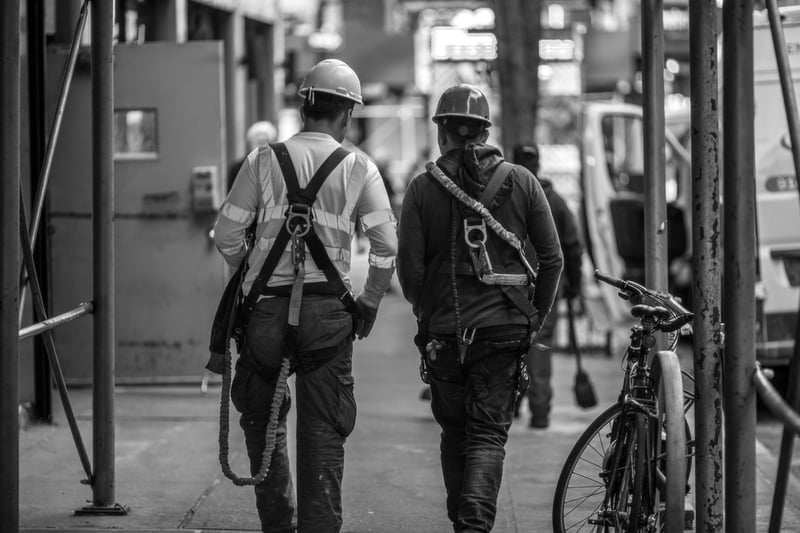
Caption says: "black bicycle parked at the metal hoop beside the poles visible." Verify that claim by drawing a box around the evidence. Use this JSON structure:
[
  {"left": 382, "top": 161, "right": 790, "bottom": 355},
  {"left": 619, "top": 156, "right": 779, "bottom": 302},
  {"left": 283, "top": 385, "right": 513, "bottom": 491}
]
[{"left": 553, "top": 270, "right": 694, "bottom": 533}]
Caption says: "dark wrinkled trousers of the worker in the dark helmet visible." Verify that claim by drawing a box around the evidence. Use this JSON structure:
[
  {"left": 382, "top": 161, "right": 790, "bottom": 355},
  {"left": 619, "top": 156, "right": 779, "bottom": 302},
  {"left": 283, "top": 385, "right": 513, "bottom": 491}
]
[{"left": 427, "top": 331, "right": 526, "bottom": 532}]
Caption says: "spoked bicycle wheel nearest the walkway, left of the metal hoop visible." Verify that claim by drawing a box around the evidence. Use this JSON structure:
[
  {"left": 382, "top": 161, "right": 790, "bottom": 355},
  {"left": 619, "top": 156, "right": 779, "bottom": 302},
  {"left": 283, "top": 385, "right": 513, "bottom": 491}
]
[{"left": 553, "top": 404, "right": 646, "bottom": 533}]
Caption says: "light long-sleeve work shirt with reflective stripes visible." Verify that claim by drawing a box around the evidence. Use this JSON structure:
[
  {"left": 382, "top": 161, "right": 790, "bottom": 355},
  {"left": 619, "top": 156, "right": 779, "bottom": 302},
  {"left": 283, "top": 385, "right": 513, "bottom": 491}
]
[{"left": 214, "top": 132, "right": 397, "bottom": 307}]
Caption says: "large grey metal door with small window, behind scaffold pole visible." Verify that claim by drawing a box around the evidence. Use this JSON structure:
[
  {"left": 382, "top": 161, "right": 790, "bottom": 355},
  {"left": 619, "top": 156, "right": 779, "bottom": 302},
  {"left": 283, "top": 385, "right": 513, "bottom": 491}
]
[{"left": 48, "top": 42, "right": 226, "bottom": 382}]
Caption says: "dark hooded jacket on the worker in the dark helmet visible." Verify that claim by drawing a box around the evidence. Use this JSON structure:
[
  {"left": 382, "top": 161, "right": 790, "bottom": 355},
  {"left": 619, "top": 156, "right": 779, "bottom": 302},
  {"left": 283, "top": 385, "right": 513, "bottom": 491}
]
[{"left": 397, "top": 144, "right": 563, "bottom": 336}]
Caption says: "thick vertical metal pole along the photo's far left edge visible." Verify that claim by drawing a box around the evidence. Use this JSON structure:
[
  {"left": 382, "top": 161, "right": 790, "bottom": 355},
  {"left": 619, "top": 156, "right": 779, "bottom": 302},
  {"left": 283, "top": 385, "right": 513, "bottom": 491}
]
[{"left": 0, "top": 2, "right": 21, "bottom": 532}]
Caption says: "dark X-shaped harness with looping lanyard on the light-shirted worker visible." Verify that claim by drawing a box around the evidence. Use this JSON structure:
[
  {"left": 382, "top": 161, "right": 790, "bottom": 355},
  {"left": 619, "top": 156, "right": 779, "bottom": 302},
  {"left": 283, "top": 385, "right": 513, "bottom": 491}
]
[{"left": 219, "top": 143, "right": 357, "bottom": 486}]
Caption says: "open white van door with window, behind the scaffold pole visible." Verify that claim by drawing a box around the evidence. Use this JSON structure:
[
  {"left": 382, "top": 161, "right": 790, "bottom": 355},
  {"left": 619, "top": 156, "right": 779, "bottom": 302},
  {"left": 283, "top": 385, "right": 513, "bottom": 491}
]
[{"left": 582, "top": 102, "right": 691, "bottom": 321}]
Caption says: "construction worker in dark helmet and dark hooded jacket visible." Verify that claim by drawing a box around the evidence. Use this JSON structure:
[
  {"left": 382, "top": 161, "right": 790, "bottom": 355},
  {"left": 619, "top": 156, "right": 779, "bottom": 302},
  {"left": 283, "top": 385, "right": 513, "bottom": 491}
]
[{"left": 397, "top": 84, "right": 562, "bottom": 532}]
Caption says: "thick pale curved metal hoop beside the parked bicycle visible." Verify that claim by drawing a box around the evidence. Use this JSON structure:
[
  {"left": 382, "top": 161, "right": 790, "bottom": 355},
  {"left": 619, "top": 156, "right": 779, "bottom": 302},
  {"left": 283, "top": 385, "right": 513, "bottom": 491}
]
[{"left": 642, "top": 351, "right": 692, "bottom": 533}]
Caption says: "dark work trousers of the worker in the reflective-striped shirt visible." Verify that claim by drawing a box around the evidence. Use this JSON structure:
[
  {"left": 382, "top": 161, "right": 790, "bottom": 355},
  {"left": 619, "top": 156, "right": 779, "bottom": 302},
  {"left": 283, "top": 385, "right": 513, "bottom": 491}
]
[{"left": 231, "top": 295, "right": 356, "bottom": 533}]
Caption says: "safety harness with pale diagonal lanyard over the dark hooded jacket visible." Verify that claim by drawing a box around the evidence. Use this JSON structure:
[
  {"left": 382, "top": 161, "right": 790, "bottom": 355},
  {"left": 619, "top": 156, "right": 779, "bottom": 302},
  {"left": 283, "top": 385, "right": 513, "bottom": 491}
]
[{"left": 415, "top": 161, "right": 536, "bottom": 394}]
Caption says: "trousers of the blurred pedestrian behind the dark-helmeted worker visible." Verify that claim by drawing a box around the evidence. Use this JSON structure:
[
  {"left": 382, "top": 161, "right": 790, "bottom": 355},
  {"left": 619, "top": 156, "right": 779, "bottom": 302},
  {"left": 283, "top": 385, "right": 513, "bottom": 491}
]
[{"left": 526, "top": 305, "right": 558, "bottom": 420}]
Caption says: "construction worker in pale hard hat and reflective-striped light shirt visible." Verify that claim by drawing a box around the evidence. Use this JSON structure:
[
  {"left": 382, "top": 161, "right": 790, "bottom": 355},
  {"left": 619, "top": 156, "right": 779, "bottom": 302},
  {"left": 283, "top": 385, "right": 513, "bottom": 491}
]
[{"left": 214, "top": 59, "right": 397, "bottom": 533}]
